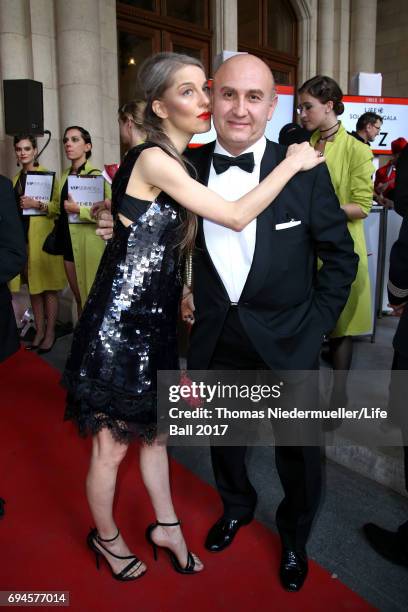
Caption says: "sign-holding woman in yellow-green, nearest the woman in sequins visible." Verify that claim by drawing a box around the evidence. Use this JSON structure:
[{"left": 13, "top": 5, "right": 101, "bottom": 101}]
[{"left": 50, "top": 126, "right": 110, "bottom": 316}]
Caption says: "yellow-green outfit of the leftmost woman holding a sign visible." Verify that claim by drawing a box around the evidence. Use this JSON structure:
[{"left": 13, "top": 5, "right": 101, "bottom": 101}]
[{"left": 9, "top": 166, "right": 67, "bottom": 295}]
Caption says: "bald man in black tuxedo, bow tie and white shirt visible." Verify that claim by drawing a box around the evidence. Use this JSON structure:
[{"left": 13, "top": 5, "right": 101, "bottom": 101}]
[{"left": 98, "top": 54, "right": 358, "bottom": 591}]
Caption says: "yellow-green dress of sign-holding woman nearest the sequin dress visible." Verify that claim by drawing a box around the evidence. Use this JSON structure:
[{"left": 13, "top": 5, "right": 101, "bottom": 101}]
[{"left": 53, "top": 161, "right": 111, "bottom": 306}]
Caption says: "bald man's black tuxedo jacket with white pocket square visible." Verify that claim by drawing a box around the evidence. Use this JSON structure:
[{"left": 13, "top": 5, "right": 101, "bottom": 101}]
[{"left": 188, "top": 141, "right": 358, "bottom": 370}]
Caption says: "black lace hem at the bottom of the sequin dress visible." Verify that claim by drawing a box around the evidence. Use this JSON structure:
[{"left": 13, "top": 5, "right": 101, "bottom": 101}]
[{"left": 61, "top": 372, "right": 157, "bottom": 444}]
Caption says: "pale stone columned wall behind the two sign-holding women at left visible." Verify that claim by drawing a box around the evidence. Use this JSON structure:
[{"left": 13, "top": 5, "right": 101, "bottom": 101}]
[{"left": 0, "top": 0, "right": 120, "bottom": 176}]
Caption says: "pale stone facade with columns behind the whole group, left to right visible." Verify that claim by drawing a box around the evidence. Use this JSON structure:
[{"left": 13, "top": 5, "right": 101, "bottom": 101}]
[{"left": 0, "top": 0, "right": 402, "bottom": 176}]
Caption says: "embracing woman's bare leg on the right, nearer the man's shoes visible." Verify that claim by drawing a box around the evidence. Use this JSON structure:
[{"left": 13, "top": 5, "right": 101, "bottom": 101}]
[{"left": 140, "top": 441, "right": 204, "bottom": 571}]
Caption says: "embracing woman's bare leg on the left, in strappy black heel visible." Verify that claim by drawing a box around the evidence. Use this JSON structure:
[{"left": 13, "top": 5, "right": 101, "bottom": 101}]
[{"left": 86, "top": 428, "right": 146, "bottom": 576}]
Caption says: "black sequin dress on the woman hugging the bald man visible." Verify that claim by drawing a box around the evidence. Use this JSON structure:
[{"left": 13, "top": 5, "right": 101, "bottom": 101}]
[{"left": 62, "top": 143, "right": 182, "bottom": 442}]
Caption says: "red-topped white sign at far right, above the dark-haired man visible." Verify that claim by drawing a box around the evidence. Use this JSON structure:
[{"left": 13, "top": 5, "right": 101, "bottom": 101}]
[{"left": 340, "top": 96, "right": 408, "bottom": 155}]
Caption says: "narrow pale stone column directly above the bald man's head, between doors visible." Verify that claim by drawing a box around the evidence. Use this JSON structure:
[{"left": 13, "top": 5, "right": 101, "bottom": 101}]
[{"left": 211, "top": 0, "right": 238, "bottom": 70}]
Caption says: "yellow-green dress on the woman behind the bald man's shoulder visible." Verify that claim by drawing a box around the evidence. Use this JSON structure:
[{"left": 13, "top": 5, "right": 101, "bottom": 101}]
[{"left": 310, "top": 124, "right": 375, "bottom": 338}]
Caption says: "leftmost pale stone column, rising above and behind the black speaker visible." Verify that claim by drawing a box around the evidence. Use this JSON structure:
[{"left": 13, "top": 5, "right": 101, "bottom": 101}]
[{"left": 0, "top": 0, "right": 33, "bottom": 177}]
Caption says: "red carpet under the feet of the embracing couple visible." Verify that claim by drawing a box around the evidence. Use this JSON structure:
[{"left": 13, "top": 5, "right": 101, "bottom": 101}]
[{"left": 0, "top": 350, "right": 373, "bottom": 612}]
